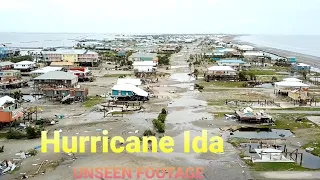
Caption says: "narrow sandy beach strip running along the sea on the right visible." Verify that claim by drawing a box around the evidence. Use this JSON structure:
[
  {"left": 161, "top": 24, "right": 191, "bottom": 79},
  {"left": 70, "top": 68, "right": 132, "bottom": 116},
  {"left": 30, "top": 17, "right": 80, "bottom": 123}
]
[{"left": 233, "top": 39, "right": 320, "bottom": 68}]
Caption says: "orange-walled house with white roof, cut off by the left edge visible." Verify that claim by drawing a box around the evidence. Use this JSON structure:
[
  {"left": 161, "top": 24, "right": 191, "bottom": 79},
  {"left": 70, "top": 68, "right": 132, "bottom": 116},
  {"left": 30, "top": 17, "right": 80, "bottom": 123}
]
[{"left": 0, "top": 96, "right": 23, "bottom": 127}]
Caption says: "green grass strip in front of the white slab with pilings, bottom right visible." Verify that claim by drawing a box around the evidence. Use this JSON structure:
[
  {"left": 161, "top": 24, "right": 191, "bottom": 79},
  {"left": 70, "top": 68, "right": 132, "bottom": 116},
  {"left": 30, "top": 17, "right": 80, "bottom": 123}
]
[{"left": 245, "top": 160, "right": 312, "bottom": 171}]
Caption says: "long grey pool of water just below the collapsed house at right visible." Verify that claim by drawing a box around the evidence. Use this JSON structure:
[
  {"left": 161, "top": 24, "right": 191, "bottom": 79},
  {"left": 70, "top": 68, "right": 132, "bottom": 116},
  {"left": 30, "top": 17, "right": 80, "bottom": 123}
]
[{"left": 230, "top": 129, "right": 292, "bottom": 139}]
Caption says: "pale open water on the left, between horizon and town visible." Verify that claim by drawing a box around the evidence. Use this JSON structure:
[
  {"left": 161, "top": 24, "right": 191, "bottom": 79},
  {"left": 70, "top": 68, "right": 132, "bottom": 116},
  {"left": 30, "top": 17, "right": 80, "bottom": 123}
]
[{"left": 0, "top": 32, "right": 119, "bottom": 48}]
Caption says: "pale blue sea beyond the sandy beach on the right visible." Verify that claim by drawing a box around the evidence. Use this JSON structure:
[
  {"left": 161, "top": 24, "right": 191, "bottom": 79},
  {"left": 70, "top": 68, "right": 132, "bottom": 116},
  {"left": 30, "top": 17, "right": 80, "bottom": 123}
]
[{"left": 236, "top": 35, "right": 320, "bottom": 57}]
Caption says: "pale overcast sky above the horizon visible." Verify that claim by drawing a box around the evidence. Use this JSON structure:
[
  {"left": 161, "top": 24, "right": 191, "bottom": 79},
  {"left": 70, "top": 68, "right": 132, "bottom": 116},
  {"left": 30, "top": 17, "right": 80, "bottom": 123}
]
[{"left": 0, "top": 0, "right": 320, "bottom": 35}]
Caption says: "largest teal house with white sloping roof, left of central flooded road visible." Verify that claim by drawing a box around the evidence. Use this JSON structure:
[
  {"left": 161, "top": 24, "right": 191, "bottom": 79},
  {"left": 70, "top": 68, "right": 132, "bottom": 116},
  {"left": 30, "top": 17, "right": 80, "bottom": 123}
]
[{"left": 111, "top": 84, "right": 149, "bottom": 101}]
